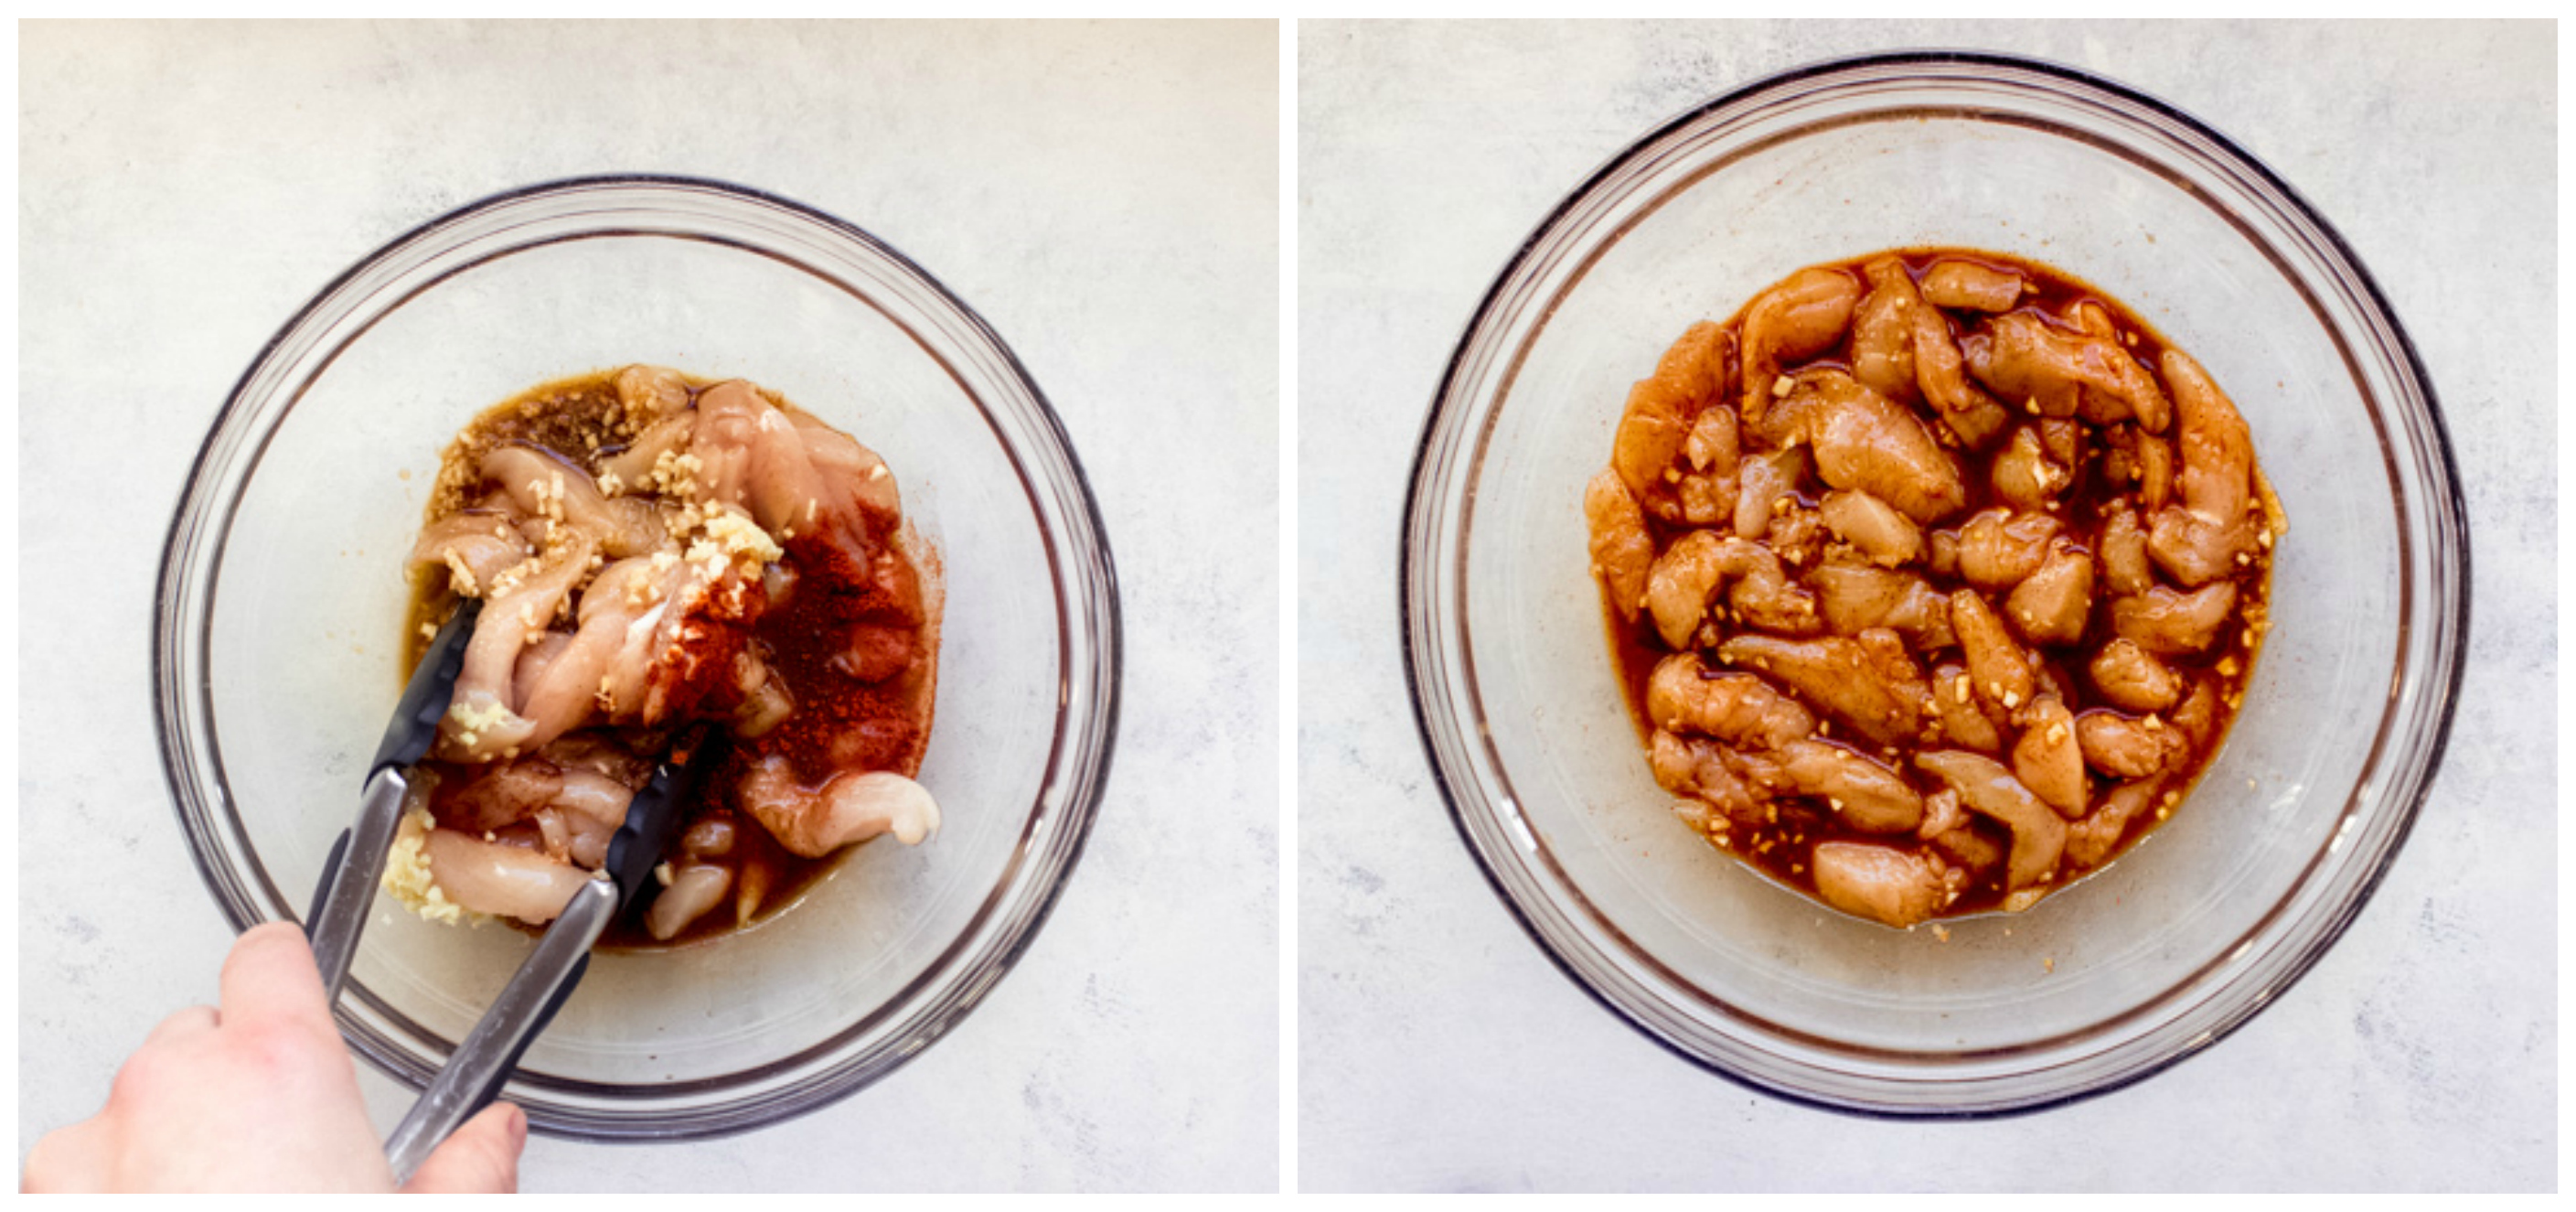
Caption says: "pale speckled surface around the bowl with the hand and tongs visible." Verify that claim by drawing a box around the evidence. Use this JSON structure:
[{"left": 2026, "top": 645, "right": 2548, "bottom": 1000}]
[{"left": 18, "top": 23, "right": 1280, "bottom": 1191}]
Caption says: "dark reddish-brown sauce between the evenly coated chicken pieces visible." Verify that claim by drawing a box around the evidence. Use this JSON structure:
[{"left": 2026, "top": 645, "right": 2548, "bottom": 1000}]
[{"left": 1598, "top": 248, "right": 2287, "bottom": 920}]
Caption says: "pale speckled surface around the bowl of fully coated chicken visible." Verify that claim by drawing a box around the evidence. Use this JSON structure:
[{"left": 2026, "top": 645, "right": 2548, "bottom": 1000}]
[{"left": 1299, "top": 21, "right": 2558, "bottom": 1191}]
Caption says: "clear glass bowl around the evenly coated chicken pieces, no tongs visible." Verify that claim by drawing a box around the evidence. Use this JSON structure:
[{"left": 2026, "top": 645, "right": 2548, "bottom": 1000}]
[{"left": 1401, "top": 54, "right": 2468, "bottom": 1117}]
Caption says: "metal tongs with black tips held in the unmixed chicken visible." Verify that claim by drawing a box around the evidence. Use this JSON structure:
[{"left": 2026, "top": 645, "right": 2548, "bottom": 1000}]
[{"left": 304, "top": 598, "right": 706, "bottom": 1181}]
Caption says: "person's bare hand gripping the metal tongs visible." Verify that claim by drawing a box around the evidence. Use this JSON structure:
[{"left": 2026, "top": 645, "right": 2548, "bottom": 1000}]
[{"left": 18, "top": 923, "right": 528, "bottom": 1194}]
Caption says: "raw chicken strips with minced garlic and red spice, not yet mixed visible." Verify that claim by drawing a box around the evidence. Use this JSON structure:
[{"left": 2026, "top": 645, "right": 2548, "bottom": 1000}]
[{"left": 387, "top": 366, "right": 940, "bottom": 947}]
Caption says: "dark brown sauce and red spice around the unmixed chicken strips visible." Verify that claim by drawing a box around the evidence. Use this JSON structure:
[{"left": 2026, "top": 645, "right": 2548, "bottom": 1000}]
[{"left": 417, "top": 369, "right": 937, "bottom": 949}]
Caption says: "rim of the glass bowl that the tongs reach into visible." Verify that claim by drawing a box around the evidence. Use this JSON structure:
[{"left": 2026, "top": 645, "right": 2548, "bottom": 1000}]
[{"left": 149, "top": 173, "right": 1126, "bottom": 1142}]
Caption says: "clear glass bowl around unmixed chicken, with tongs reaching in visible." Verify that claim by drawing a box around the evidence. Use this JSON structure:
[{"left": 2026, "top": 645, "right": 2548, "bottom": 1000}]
[{"left": 152, "top": 178, "right": 1118, "bottom": 1140}]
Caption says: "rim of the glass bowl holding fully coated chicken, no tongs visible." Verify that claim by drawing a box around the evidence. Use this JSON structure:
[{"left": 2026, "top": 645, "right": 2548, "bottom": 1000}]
[{"left": 1396, "top": 49, "right": 2473, "bottom": 1121}]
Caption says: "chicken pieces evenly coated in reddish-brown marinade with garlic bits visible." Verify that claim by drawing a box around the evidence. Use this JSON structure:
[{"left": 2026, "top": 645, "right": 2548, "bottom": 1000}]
[{"left": 1584, "top": 248, "right": 2287, "bottom": 926}]
